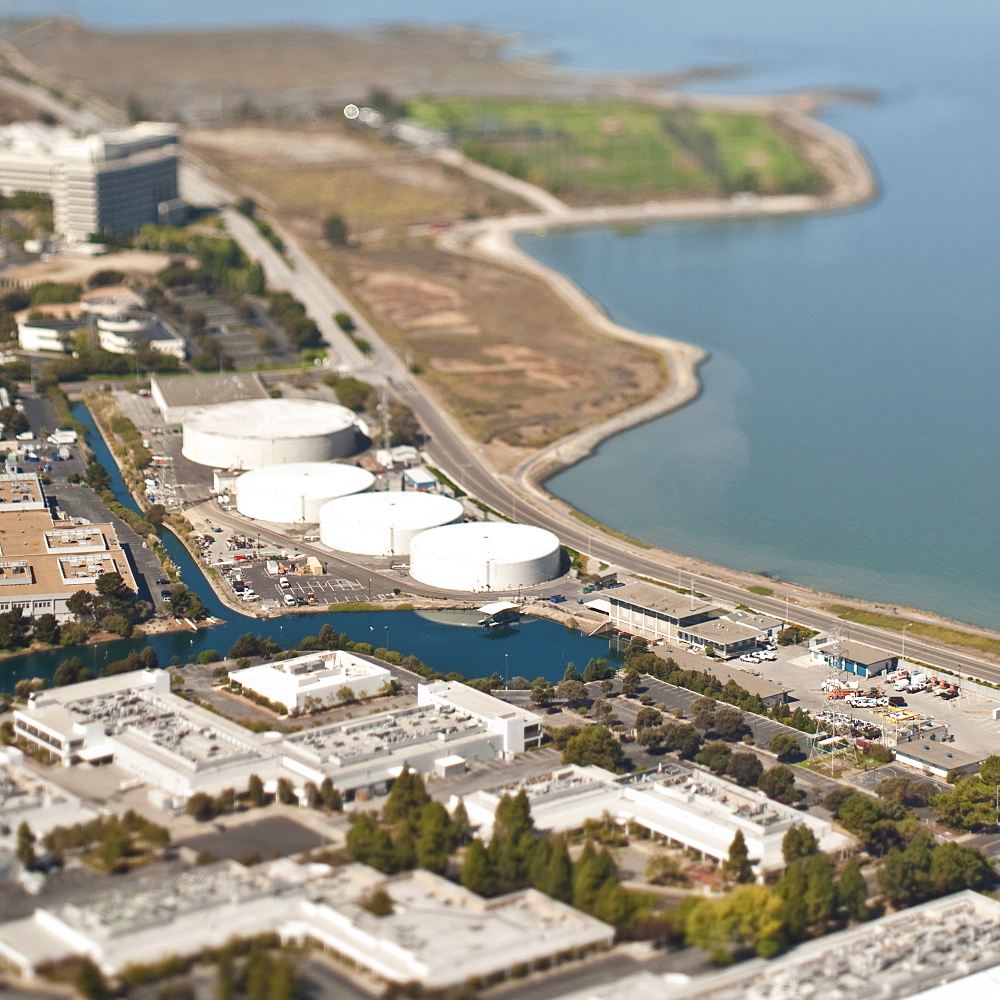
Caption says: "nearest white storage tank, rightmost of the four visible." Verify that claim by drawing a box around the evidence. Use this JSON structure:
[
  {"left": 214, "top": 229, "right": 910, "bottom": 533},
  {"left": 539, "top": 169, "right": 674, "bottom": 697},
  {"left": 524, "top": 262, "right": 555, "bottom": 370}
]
[{"left": 410, "top": 522, "right": 561, "bottom": 592}]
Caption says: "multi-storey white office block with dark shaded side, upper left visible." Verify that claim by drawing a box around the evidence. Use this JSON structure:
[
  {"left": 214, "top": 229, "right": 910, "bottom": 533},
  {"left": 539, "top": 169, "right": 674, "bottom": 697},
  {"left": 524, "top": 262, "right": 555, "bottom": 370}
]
[{"left": 0, "top": 122, "right": 179, "bottom": 243}]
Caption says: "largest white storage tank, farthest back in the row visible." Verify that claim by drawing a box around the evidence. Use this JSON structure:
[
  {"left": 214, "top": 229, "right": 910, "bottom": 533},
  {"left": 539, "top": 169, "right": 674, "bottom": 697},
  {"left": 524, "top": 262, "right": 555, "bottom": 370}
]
[{"left": 181, "top": 399, "right": 356, "bottom": 469}]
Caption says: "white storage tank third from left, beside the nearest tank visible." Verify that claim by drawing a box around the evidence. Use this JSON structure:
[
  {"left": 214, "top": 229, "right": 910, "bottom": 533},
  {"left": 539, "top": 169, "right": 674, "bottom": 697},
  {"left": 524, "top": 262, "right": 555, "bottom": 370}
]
[{"left": 319, "top": 493, "right": 462, "bottom": 556}]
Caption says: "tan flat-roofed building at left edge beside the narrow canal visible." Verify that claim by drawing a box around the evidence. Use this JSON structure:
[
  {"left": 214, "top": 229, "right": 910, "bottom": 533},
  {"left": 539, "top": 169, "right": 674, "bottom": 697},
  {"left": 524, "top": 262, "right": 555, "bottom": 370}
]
[{"left": 0, "top": 473, "right": 137, "bottom": 621}]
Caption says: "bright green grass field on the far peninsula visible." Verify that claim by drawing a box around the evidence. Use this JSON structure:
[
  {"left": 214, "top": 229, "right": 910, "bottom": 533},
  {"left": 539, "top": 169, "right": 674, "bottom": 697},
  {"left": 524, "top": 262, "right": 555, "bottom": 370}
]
[{"left": 409, "top": 98, "right": 823, "bottom": 202}]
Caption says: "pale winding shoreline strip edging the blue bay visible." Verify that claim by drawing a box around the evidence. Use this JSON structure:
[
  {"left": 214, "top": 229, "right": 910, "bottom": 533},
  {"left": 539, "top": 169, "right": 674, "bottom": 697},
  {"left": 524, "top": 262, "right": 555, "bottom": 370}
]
[{"left": 435, "top": 107, "right": 1000, "bottom": 640}]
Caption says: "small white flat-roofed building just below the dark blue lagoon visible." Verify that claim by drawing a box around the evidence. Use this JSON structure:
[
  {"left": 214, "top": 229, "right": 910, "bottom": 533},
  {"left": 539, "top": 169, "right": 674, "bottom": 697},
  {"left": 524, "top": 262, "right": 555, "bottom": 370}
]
[{"left": 229, "top": 649, "right": 392, "bottom": 712}]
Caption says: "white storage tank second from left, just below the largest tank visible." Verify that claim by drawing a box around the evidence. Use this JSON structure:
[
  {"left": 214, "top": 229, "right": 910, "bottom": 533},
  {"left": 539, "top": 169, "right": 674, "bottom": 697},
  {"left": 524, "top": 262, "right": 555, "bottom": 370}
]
[{"left": 234, "top": 462, "right": 375, "bottom": 524}]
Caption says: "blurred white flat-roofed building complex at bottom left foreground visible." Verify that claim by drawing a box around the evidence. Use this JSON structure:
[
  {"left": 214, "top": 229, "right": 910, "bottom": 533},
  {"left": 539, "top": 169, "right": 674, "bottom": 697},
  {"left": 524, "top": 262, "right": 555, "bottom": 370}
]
[{"left": 0, "top": 860, "right": 614, "bottom": 989}]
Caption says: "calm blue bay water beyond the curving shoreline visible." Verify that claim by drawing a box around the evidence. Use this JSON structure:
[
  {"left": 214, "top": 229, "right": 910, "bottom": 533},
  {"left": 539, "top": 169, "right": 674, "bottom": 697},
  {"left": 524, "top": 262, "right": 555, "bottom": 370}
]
[{"left": 7, "top": 0, "right": 1000, "bottom": 626}]
